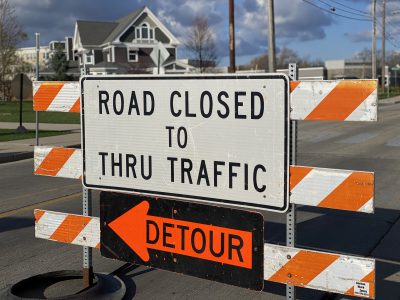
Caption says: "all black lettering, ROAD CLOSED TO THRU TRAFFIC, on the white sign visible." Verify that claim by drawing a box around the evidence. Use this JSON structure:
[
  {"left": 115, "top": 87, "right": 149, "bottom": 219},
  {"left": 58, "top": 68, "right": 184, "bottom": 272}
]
[{"left": 98, "top": 86, "right": 267, "bottom": 193}]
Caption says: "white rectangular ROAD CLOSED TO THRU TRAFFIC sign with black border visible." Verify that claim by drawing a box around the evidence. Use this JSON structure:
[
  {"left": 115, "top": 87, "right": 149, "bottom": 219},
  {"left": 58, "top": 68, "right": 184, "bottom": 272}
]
[{"left": 81, "top": 74, "right": 289, "bottom": 212}]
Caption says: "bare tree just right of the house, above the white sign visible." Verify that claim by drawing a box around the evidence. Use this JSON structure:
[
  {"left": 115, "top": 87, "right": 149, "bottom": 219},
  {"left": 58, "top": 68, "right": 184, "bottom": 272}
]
[{"left": 184, "top": 16, "right": 218, "bottom": 73}]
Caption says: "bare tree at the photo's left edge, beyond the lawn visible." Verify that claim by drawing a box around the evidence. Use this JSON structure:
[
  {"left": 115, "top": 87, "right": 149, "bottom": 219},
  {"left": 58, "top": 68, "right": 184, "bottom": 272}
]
[{"left": 0, "top": 0, "right": 26, "bottom": 100}]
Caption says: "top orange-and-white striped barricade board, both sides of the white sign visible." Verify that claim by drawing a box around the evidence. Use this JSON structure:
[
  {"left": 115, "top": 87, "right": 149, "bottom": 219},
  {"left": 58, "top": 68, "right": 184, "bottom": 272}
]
[{"left": 33, "top": 80, "right": 377, "bottom": 121}]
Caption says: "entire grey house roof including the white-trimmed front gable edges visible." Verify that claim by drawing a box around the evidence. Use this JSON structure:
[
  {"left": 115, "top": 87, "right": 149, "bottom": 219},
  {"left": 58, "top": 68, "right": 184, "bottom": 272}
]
[{"left": 77, "top": 6, "right": 179, "bottom": 46}]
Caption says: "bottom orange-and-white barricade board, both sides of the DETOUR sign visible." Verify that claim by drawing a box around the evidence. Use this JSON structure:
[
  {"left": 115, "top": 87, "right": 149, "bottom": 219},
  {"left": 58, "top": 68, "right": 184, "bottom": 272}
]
[{"left": 35, "top": 209, "right": 375, "bottom": 298}]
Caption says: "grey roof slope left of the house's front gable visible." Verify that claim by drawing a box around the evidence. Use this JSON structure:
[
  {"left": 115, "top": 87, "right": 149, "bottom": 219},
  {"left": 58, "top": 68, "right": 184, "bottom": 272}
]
[{"left": 76, "top": 20, "right": 118, "bottom": 46}]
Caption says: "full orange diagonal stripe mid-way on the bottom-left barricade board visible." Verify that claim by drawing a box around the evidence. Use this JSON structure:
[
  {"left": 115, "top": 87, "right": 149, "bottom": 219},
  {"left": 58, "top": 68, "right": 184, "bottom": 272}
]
[{"left": 50, "top": 215, "right": 91, "bottom": 244}]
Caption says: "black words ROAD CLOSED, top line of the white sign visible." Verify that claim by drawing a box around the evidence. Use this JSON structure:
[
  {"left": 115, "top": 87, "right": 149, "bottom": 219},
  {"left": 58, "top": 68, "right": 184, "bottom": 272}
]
[{"left": 98, "top": 90, "right": 265, "bottom": 119}]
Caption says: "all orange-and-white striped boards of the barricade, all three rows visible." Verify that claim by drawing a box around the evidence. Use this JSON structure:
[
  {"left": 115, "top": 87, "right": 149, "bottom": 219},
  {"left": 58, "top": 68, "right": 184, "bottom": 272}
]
[{"left": 33, "top": 80, "right": 377, "bottom": 298}]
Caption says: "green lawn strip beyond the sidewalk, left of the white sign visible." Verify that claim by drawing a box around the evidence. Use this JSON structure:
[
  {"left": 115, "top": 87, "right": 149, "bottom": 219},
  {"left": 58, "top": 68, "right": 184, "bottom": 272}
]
[{"left": 0, "top": 101, "right": 80, "bottom": 124}]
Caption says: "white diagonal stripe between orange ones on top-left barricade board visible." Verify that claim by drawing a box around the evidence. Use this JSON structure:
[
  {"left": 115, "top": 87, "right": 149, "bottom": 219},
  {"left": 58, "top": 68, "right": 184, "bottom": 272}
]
[{"left": 47, "top": 82, "right": 80, "bottom": 112}]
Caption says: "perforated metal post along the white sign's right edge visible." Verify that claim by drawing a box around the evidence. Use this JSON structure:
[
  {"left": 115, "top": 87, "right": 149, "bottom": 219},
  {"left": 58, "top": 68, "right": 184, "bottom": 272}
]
[{"left": 286, "top": 64, "right": 298, "bottom": 300}]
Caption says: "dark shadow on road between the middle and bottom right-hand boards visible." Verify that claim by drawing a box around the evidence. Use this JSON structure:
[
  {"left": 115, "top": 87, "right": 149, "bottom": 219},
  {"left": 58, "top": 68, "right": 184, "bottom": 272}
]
[{"left": 264, "top": 207, "right": 400, "bottom": 261}]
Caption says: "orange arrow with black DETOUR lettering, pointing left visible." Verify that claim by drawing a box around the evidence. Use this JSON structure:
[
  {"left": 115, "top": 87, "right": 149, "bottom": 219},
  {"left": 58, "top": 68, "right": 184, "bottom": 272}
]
[{"left": 108, "top": 201, "right": 253, "bottom": 269}]
